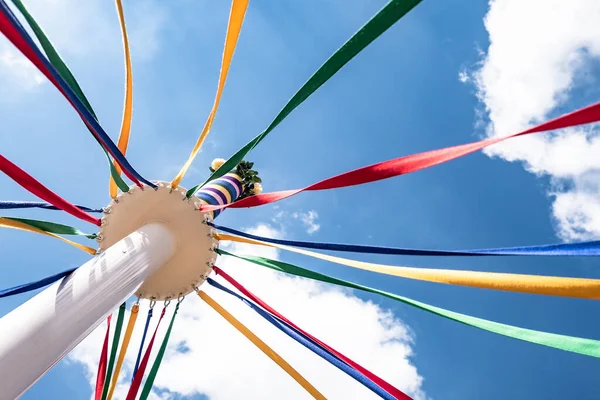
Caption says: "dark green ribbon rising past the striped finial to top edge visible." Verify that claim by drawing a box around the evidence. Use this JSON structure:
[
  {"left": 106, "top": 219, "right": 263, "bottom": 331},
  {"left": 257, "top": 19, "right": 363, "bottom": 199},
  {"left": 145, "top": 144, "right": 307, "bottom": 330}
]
[{"left": 186, "top": 0, "right": 421, "bottom": 198}]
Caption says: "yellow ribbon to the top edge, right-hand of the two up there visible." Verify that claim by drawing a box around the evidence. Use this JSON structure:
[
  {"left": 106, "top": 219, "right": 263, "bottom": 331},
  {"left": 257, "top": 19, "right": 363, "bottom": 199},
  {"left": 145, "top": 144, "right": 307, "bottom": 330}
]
[{"left": 171, "top": 0, "right": 249, "bottom": 188}]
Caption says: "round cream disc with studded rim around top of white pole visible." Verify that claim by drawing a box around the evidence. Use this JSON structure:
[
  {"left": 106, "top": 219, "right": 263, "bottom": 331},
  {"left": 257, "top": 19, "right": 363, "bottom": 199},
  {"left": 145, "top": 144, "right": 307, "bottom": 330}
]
[{"left": 98, "top": 182, "right": 218, "bottom": 300}]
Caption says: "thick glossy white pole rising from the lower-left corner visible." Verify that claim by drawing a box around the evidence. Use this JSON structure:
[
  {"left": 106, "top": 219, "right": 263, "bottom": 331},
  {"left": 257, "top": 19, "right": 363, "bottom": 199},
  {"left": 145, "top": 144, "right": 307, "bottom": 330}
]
[{"left": 0, "top": 223, "right": 175, "bottom": 400}]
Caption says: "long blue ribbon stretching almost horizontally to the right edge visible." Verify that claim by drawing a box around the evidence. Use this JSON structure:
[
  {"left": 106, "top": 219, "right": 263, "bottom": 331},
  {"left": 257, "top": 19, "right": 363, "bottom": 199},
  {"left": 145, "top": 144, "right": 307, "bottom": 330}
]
[{"left": 207, "top": 222, "right": 600, "bottom": 256}]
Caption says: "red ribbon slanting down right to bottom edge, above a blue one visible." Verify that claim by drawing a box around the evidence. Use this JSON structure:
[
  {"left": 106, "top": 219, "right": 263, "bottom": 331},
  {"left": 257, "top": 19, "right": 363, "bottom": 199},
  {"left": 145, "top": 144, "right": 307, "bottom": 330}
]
[{"left": 213, "top": 266, "right": 412, "bottom": 400}]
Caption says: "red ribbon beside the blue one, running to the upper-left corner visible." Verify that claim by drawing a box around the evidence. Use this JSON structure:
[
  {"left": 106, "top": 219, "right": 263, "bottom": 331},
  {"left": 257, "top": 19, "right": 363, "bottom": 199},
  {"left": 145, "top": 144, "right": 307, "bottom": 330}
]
[{"left": 0, "top": 12, "right": 142, "bottom": 187}]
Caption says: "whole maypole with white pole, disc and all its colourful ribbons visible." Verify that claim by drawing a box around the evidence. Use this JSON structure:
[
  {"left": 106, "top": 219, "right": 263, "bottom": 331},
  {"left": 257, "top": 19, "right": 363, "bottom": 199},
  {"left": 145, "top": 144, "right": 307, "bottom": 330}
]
[{"left": 0, "top": 0, "right": 600, "bottom": 400}]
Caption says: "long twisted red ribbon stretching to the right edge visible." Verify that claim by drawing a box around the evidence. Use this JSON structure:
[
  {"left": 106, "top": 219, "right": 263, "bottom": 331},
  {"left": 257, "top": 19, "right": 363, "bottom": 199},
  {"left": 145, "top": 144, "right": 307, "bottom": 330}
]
[{"left": 200, "top": 103, "right": 600, "bottom": 212}]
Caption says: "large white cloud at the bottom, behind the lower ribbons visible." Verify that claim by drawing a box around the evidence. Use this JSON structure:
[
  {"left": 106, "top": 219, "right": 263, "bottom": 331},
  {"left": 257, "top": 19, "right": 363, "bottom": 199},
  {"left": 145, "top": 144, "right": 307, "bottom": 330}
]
[{"left": 69, "top": 225, "right": 425, "bottom": 400}]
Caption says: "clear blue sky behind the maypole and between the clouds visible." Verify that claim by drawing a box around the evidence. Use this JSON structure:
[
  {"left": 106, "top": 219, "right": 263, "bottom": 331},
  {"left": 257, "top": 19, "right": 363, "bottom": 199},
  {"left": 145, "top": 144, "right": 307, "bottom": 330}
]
[{"left": 0, "top": 0, "right": 600, "bottom": 399}]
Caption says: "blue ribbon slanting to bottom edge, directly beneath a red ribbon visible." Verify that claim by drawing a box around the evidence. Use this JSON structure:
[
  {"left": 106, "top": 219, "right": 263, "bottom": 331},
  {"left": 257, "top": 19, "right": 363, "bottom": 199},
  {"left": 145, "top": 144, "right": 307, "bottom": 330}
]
[{"left": 207, "top": 278, "right": 395, "bottom": 400}]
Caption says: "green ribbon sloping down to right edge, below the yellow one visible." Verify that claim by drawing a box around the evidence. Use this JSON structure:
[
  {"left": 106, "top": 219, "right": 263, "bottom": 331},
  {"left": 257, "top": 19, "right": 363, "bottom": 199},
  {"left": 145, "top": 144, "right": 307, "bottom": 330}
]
[{"left": 216, "top": 249, "right": 600, "bottom": 358}]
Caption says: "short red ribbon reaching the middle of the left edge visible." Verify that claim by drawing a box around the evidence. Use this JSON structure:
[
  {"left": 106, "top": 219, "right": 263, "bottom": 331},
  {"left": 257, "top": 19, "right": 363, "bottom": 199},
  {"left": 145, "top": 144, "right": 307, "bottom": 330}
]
[{"left": 0, "top": 155, "right": 101, "bottom": 226}]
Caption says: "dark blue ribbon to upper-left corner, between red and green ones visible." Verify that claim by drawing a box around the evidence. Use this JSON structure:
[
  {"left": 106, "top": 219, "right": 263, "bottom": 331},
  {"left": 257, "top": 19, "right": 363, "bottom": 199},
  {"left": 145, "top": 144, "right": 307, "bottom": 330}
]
[{"left": 0, "top": 0, "right": 156, "bottom": 188}]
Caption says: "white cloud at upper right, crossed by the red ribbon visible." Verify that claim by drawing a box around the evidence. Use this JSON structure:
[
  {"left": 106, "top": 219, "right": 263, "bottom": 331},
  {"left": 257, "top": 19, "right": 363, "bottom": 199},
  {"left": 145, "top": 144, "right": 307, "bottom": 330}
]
[{"left": 472, "top": 0, "right": 600, "bottom": 240}]
